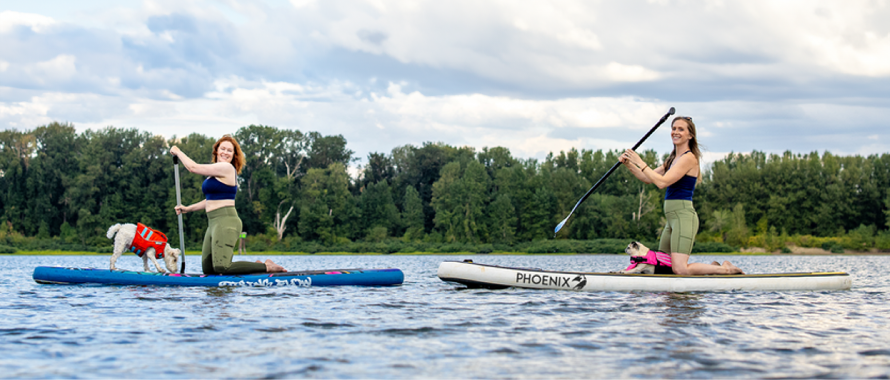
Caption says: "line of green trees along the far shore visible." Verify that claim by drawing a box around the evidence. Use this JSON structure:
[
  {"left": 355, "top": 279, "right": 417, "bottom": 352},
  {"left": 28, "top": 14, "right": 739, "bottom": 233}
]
[{"left": 0, "top": 123, "right": 890, "bottom": 250}]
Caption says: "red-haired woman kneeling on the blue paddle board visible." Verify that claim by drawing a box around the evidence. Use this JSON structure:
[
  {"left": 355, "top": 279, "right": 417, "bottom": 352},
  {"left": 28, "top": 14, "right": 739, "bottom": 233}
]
[{"left": 170, "top": 135, "right": 287, "bottom": 274}]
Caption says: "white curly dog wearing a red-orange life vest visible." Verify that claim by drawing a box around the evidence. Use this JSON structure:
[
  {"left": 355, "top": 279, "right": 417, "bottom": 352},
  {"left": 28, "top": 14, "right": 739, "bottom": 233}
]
[{"left": 107, "top": 223, "right": 182, "bottom": 273}]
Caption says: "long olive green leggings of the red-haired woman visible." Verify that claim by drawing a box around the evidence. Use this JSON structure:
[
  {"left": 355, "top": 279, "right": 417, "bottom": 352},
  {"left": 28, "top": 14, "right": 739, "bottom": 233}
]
[{"left": 201, "top": 206, "right": 266, "bottom": 274}]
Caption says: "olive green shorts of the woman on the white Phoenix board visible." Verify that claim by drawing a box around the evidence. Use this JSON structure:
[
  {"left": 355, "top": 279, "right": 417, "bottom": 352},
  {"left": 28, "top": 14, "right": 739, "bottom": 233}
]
[{"left": 658, "top": 199, "right": 698, "bottom": 255}]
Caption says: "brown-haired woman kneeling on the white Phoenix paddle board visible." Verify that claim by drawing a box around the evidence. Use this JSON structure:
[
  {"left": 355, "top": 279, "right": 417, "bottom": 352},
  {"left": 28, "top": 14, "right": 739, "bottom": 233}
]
[{"left": 618, "top": 116, "right": 744, "bottom": 275}]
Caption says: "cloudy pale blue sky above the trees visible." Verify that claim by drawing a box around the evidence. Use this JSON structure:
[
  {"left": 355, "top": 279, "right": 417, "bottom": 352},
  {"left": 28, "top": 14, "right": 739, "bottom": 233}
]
[{"left": 0, "top": 0, "right": 890, "bottom": 169}]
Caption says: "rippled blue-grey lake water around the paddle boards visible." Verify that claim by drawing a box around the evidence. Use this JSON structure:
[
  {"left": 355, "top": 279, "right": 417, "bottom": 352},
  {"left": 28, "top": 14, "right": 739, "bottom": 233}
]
[{"left": 0, "top": 255, "right": 890, "bottom": 379}]
